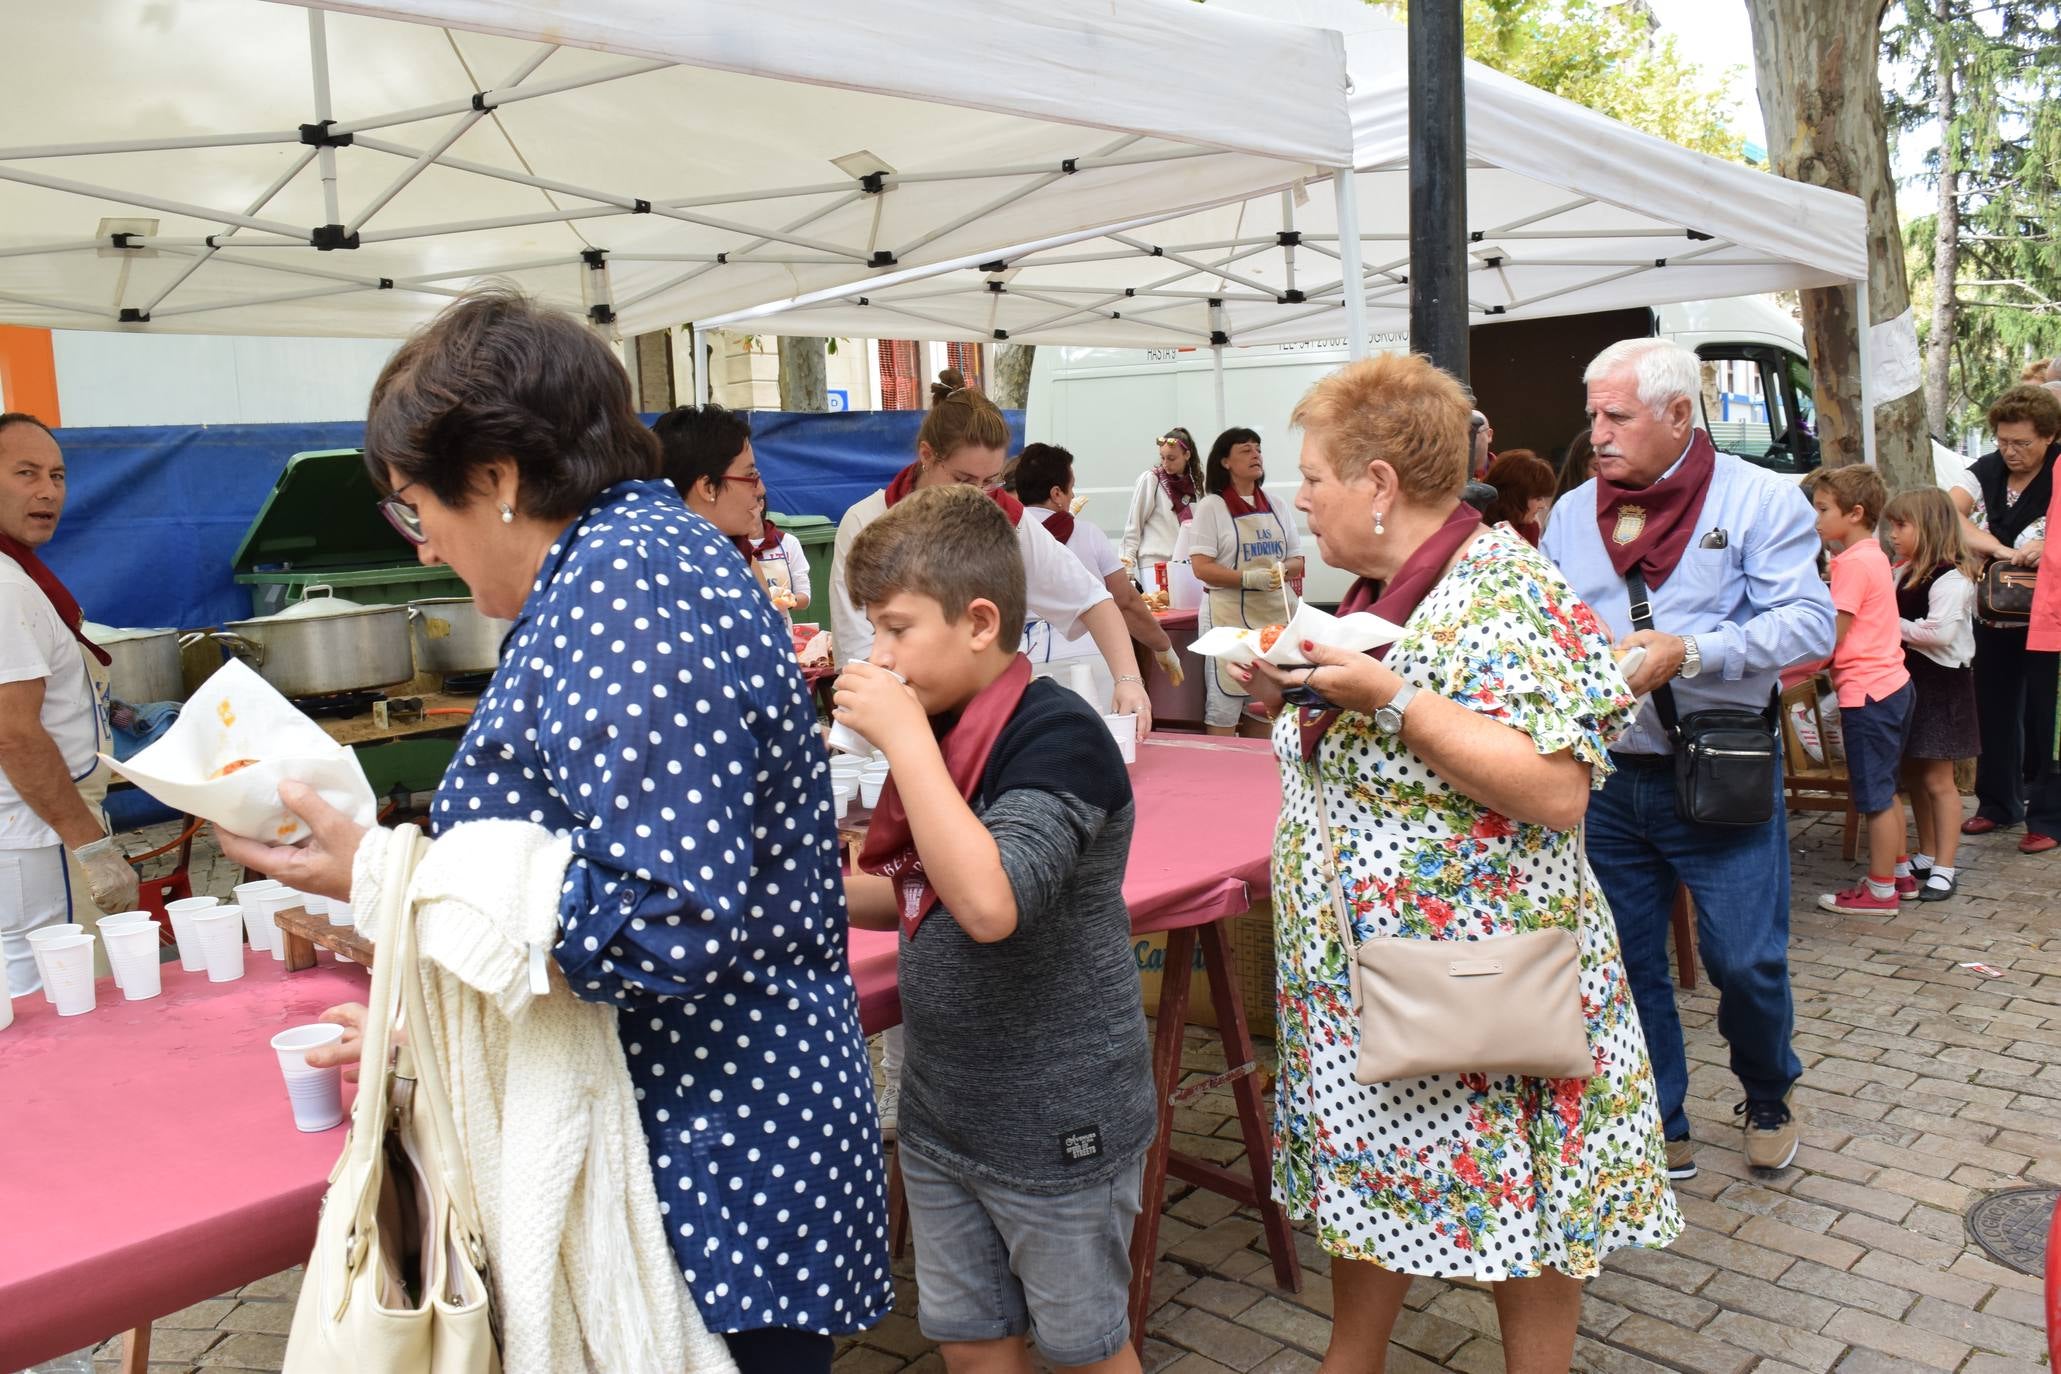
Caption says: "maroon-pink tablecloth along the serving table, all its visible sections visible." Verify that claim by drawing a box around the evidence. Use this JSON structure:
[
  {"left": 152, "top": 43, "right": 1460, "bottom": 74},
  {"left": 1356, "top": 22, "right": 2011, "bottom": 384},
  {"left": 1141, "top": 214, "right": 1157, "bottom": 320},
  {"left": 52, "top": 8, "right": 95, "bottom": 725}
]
[{"left": 0, "top": 735, "right": 1280, "bottom": 1370}]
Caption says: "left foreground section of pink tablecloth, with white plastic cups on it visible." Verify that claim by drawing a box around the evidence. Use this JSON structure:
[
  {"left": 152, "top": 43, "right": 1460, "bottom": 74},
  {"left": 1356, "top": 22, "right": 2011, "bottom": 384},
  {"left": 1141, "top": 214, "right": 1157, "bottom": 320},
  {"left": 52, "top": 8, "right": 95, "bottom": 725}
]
[{"left": 0, "top": 956, "right": 365, "bottom": 1370}]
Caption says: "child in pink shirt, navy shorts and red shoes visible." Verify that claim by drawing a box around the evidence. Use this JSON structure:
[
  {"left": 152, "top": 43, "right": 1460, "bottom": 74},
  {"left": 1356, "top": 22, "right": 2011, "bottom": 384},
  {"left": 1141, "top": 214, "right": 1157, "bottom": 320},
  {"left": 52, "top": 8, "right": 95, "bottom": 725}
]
[{"left": 1810, "top": 463, "right": 1917, "bottom": 917}]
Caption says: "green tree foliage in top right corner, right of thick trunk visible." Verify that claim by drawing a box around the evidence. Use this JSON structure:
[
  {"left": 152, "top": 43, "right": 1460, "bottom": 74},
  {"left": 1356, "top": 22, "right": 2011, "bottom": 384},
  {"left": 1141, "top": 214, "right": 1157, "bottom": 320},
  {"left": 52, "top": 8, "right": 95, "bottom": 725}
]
[{"left": 1884, "top": 0, "right": 2061, "bottom": 433}]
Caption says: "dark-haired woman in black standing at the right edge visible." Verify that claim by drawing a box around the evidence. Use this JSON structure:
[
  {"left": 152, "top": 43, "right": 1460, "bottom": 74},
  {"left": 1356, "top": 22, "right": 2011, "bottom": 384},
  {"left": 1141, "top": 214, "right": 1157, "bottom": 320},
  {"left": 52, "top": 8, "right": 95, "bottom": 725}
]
[{"left": 1948, "top": 383, "right": 2061, "bottom": 855}]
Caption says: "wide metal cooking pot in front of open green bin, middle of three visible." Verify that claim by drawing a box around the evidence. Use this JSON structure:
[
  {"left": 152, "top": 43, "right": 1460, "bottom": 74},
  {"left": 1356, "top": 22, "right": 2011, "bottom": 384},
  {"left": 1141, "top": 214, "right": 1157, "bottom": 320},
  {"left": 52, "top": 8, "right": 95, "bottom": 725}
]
[{"left": 214, "top": 585, "right": 414, "bottom": 696}]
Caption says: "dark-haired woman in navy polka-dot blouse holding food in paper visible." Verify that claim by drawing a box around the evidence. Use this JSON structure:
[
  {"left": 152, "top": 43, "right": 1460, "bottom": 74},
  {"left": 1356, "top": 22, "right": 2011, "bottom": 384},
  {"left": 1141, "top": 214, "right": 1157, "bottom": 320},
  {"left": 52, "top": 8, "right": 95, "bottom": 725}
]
[{"left": 223, "top": 290, "right": 894, "bottom": 1374}]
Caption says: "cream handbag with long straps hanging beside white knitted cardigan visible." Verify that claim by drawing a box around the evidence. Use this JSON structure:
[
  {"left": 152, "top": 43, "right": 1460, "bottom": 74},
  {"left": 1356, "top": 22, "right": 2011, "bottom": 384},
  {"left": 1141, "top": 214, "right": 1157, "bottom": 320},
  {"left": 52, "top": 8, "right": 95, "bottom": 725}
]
[{"left": 282, "top": 826, "right": 501, "bottom": 1374}]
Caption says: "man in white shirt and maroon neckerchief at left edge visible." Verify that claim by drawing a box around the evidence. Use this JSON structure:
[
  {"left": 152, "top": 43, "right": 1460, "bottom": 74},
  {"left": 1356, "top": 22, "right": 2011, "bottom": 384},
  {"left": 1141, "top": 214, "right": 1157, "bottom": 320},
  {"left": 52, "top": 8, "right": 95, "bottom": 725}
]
[{"left": 0, "top": 412, "right": 138, "bottom": 997}]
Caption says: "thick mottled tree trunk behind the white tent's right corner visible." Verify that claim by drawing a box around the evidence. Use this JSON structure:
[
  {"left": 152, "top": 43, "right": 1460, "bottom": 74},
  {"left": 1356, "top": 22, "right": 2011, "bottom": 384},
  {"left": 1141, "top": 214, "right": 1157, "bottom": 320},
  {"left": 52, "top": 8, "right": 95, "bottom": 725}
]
[{"left": 1746, "top": 0, "right": 1933, "bottom": 488}]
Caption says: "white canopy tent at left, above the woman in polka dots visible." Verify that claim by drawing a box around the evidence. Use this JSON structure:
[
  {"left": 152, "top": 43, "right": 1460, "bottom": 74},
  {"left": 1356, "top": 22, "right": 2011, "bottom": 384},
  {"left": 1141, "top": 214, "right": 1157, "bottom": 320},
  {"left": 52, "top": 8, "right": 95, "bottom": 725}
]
[{"left": 0, "top": 0, "right": 1352, "bottom": 336}]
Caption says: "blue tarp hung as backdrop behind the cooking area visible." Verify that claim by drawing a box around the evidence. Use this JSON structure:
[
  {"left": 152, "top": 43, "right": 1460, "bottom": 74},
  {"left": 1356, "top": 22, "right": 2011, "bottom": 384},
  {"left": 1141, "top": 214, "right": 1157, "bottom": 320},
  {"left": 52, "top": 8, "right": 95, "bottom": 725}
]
[{"left": 43, "top": 410, "right": 1022, "bottom": 628}]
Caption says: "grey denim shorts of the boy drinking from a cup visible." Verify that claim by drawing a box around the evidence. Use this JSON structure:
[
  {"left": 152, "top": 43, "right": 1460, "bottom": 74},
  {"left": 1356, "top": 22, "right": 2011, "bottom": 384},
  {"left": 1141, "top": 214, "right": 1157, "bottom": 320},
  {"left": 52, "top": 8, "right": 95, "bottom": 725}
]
[{"left": 901, "top": 1145, "right": 1144, "bottom": 1364}]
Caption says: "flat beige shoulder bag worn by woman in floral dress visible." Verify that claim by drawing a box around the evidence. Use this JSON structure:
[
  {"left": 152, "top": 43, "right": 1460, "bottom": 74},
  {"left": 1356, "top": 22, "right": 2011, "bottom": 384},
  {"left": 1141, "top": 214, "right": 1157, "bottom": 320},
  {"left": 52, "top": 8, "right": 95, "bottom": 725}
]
[{"left": 1317, "top": 772, "right": 1595, "bottom": 1084}]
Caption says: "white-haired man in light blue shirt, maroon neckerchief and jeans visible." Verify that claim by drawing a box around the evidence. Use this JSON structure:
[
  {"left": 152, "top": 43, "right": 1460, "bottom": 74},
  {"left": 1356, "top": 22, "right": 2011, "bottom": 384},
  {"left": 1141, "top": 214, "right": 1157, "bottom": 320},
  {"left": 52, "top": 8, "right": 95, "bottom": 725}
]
[{"left": 1542, "top": 338, "right": 1834, "bottom": 1178}]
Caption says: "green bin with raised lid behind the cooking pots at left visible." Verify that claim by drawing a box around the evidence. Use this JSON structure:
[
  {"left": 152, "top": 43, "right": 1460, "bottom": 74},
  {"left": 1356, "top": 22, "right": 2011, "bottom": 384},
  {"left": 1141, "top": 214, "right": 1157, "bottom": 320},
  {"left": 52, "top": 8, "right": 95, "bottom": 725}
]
[{"left": 235, "top": 449, "right": 472, "bottom": 616}]
